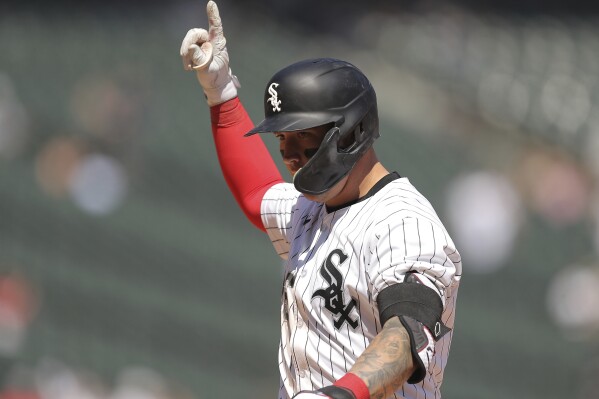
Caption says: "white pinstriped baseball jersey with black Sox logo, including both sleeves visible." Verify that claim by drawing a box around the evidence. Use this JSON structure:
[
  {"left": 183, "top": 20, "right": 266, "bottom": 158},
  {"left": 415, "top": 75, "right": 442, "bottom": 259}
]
[{"left": 262, "top": 174, "right": 461, "bottom": 399}]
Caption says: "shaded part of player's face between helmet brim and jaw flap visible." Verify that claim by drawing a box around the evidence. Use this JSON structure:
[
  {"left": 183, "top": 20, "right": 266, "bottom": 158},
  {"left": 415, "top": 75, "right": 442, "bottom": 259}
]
[{"left": 275, "top": 126, "right": 328, "bottom": 176}]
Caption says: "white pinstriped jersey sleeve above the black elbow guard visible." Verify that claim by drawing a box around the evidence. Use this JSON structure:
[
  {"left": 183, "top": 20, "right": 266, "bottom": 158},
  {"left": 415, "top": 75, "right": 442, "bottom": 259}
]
[{"left": 367, "top": 214, "right": 461, "bottom": 306}]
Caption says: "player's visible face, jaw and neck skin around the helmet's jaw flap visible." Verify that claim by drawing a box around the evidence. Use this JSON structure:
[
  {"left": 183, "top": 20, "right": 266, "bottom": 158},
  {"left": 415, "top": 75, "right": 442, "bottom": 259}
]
[{"left": 275, "top": 126, "right": 389, "bottom": 207}]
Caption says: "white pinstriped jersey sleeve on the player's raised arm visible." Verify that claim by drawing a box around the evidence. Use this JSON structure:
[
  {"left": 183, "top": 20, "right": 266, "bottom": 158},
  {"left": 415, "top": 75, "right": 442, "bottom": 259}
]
[{"left": 261, "top": 183, "right": 303, "bottom": 259}]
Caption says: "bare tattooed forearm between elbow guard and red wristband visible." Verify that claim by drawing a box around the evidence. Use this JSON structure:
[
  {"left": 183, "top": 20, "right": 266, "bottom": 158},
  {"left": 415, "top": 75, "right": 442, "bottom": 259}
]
[{"left": 351, "top": 317, "right": 414, "bottom": 399}]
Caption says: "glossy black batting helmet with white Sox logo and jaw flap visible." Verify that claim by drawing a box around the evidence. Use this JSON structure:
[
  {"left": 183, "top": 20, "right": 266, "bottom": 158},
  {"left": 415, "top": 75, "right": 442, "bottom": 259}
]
[{"left": 246, "top": 58, "right": 379, "bottom": 195}]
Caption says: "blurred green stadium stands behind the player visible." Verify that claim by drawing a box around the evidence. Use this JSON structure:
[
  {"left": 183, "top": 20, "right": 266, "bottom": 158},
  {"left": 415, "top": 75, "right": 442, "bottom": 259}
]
[{"left": 0, "top": 1, "right": 599, "bottom": 399}]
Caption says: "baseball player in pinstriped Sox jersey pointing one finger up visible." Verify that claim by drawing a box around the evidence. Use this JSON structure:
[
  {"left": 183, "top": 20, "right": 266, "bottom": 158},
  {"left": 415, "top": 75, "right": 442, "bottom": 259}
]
[{"left": 181, "top": 1, "right": 461, "bottom": 399}]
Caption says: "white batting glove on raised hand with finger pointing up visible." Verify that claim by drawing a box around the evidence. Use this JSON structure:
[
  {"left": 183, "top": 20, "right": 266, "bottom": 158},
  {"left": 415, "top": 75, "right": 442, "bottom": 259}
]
[{"left": 181, "top": 0, "right": 239, "bottom": 107}]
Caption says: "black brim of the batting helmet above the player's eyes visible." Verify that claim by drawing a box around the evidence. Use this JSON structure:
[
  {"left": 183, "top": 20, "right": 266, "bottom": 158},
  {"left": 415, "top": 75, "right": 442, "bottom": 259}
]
[{"left": 244, "top": 112, "right": 343, "bottom": 137}]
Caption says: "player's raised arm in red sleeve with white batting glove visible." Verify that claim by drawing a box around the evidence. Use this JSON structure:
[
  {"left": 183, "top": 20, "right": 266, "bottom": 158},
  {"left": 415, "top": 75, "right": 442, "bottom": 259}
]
[{"left": 181, "top": 1, "right": 283, "bottom": 231}]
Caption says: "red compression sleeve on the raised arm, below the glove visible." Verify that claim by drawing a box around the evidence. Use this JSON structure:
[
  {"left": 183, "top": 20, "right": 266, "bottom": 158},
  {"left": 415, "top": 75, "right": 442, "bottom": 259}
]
[{"left": 210, "top": 97, "right": 283, "bottom": 231}]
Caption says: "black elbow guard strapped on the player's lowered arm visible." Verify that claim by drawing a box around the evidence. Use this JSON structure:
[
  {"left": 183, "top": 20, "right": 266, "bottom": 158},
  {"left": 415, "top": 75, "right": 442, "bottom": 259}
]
[{"left": 377, "top": 276, "right": 450, "bottom": 384}]
